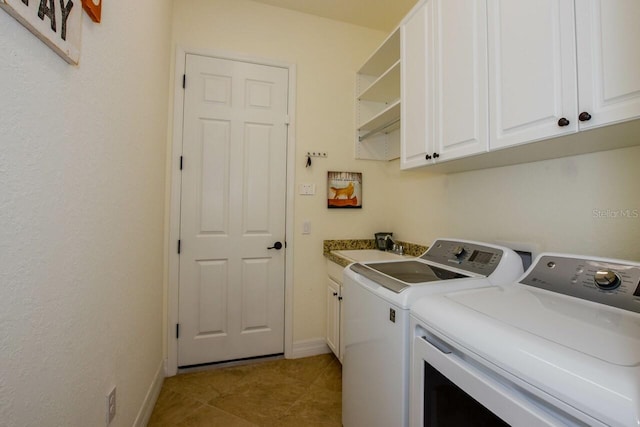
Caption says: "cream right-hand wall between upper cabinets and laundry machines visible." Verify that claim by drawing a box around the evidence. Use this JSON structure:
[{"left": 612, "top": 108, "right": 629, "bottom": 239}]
[{"left": 388, "top": 145, "right": 640, "bottom": 261}]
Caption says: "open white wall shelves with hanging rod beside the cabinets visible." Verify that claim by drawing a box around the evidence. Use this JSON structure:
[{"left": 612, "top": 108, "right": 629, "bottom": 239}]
[{"left": 355, "top": 30, "right": 400, "bottom": 160}]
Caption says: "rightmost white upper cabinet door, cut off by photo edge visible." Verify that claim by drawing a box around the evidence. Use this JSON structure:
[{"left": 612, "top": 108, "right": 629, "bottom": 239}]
[{"left": 576, "top": 0, "right": 640, "bottom": 129}]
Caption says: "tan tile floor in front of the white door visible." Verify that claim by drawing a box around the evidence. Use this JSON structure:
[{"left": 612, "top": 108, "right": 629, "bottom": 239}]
[{"left": 148, "top": 354, "right": 342, "bottom": 427}]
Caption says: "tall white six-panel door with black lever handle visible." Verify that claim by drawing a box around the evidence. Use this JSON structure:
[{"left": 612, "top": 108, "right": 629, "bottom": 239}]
[{"left": 178, "top": 55, "right": 288, "bottom": 366}]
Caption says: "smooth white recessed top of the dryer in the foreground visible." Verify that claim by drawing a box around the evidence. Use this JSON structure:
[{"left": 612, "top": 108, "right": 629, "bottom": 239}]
[{"left": 449, "top": 285, "right": 640, "bottom": 366}]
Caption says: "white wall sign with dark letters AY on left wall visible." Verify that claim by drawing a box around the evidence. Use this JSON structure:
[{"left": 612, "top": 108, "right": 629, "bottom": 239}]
[{"left": 0, "top": 0, "right": 82, "bottom": 64}]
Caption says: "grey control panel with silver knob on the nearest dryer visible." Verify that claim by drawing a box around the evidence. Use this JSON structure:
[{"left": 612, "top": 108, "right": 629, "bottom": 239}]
[{"left": 520, "top": 254, "right": 640, "bottom": 313}]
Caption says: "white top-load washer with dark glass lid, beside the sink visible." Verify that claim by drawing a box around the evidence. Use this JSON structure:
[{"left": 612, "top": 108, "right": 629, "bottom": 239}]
[{"left": 342, "top": 239, "right": 523, "bottom": 427}]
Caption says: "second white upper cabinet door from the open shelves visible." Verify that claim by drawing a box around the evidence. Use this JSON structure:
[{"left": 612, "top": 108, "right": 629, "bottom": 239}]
[{"left": 435, "top": 0, "right": 489, "bottom": 160}]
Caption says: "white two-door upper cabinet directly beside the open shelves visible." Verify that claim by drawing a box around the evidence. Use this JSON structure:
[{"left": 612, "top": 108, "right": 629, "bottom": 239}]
[{"left": 400, "top": 0, "right": 489, "bottom": 169}]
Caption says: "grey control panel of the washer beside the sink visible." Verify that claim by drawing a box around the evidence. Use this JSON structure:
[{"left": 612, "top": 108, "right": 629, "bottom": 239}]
[{"left": 420, "top": 240, "right": 503, "bottom": 276}]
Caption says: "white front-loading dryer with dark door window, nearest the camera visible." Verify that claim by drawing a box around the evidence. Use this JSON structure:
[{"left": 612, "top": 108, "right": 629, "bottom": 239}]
[{"left": 410, "top": 253, "right": 640, "bottom": 427}]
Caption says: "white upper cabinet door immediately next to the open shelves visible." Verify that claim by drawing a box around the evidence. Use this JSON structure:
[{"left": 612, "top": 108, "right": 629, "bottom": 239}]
[{"left": 400, "top": 1, "right": 434, "bottom": 169}]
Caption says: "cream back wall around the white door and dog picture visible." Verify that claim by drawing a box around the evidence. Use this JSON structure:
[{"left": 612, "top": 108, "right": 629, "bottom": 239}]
[{"left": 173, "top": 0, "right": 400, "bottom": 348}]
